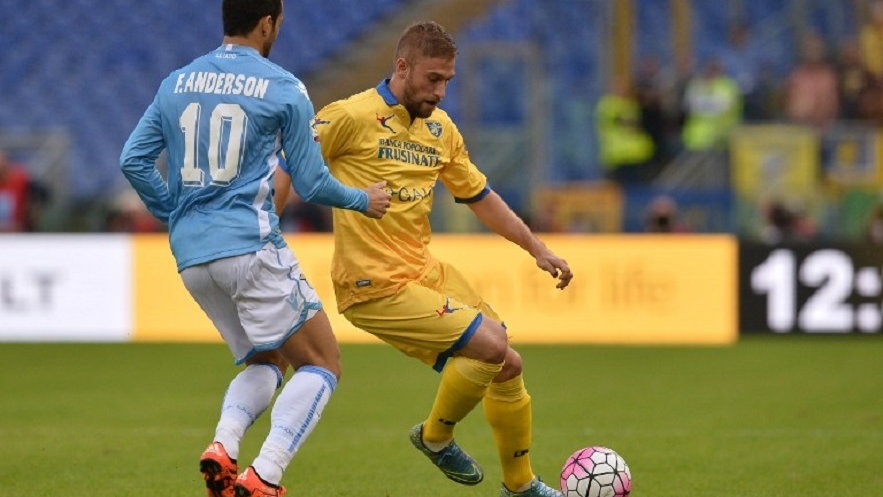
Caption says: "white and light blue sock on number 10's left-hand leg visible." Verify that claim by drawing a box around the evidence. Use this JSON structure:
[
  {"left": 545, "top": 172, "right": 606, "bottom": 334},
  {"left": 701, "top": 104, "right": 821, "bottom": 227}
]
[{"left": 215, "top": 364, "right": 282, "bottom": 459}]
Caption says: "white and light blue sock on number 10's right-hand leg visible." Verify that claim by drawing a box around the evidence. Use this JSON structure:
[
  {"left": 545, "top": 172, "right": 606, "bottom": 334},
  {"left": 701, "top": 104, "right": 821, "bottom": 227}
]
[{"left": 252, "top": 366, "right": 337, "bottom": 485}]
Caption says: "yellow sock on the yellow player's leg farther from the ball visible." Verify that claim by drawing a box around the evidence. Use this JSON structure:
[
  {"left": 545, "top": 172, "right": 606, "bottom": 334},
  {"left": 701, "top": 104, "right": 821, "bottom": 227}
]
[{"left": 423, "top": 357, "right": 503, "bottom": 449}]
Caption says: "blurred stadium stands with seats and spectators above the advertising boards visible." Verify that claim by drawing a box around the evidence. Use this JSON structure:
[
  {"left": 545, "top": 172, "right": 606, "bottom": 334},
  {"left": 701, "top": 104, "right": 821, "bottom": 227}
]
[{"left": 0, "top": 0, "right": 883, "bottom": 243}]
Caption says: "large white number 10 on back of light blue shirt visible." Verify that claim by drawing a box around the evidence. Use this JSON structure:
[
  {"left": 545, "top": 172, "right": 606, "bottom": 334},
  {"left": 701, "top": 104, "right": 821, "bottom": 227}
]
[{"left": 178, "top": 102, "right": 248, "bottom": 187}]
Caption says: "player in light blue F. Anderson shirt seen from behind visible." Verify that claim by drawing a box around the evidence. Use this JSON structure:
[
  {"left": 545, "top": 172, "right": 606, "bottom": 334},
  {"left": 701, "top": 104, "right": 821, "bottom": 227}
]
[{"left": 120, "top": 0, "right": 390, "bottom": 497}]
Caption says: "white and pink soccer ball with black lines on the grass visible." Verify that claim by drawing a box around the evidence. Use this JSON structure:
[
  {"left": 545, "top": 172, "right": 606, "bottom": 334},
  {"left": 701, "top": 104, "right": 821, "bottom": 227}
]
[{"left": 561, "top": 446, "right": 632, "bottom": 497}]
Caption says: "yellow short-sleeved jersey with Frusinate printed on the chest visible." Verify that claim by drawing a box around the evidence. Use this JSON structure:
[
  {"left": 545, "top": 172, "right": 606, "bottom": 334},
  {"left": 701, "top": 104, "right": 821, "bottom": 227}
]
[{"left": 314, "top": 81, "right": 490, "bottom": 312}]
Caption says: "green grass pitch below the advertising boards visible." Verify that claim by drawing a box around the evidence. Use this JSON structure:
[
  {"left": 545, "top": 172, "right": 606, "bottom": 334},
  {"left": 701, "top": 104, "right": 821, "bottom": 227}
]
[{"left": 0, "top": 337, "right": 883, "bottom": 497}]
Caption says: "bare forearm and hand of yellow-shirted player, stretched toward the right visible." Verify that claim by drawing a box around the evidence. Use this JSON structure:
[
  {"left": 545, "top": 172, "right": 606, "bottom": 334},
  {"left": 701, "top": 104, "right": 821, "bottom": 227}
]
[{"left": 468, "top": 191, "right": 573, "bottom": 289}]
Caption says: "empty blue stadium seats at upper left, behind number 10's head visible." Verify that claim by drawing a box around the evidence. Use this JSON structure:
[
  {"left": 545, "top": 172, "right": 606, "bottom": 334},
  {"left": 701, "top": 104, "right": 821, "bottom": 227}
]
[{"left": 0, "top": 0, "right": 409, "bottom": 198}]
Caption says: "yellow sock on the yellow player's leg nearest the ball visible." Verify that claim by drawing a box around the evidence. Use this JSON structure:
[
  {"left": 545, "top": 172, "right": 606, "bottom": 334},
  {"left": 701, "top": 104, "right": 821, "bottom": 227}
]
[{"left": 484, "top": 375, "right": 535, "bottom": 492}]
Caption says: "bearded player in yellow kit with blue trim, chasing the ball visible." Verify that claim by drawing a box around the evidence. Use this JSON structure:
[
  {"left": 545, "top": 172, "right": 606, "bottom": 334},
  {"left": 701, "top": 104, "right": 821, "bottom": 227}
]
[{"left": 278, "top": 22, "right": 573, "bottom": 497}]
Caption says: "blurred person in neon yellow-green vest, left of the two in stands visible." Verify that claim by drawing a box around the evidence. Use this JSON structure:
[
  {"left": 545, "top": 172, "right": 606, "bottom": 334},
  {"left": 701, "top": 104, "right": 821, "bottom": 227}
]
[{"left": 596, "top": 79, "right": 653, "bottom": 185}]
